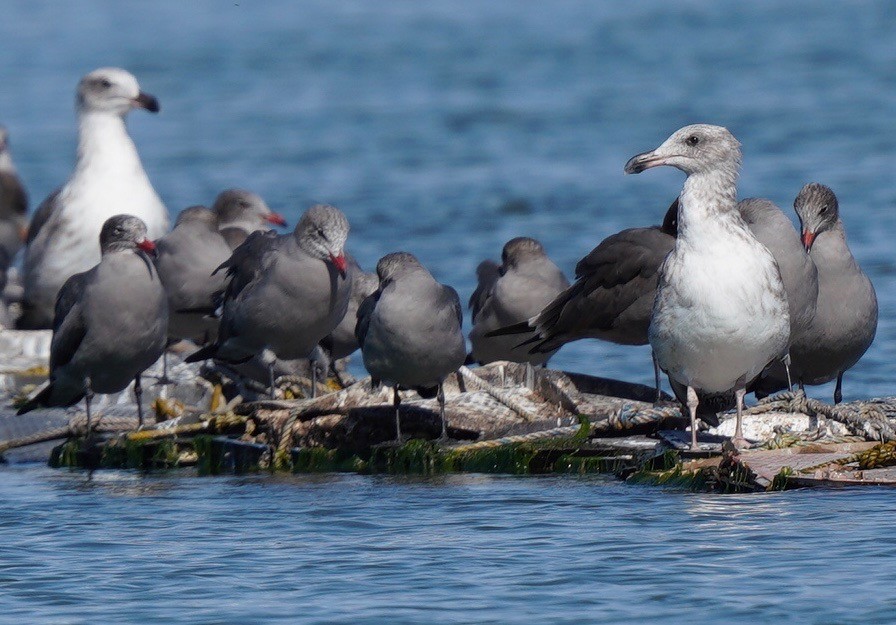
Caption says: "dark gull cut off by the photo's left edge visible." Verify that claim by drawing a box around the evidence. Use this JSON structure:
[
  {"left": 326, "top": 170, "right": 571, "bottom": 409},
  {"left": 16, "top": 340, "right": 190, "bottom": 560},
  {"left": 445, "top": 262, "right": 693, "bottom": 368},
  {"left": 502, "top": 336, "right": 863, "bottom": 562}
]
[{"left": 0, "top": 126, "right": 28, "bottom": 291}]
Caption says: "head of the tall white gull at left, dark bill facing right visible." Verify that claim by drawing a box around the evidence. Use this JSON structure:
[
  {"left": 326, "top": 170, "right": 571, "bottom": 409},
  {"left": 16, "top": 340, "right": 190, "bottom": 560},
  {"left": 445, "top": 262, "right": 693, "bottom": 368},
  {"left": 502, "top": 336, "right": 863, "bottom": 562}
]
[{"left": 77, "top": 67, "right": 159, "bottom": 117}]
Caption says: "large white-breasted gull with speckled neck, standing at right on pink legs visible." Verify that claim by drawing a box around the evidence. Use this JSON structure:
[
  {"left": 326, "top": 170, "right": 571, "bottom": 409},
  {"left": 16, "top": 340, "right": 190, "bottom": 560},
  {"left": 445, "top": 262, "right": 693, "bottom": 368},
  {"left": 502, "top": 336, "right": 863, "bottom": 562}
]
[{"left": 625, "top": 124, "right": 790, "bottom": 449}]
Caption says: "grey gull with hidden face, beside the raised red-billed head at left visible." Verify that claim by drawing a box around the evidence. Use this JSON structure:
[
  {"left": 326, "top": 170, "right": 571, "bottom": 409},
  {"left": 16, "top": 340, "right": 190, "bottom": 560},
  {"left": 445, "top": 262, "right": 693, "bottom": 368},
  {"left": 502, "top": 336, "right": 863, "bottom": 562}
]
[{"left": 155, "top": 206, "right": 231, "bottom": 343}]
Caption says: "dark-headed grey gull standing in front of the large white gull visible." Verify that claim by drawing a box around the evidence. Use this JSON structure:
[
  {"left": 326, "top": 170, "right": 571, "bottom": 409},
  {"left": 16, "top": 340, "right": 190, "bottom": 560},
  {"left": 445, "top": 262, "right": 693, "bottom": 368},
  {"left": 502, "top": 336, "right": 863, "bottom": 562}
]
[{"left": 18, "top": 215, "right": 168, "bottom": 434}]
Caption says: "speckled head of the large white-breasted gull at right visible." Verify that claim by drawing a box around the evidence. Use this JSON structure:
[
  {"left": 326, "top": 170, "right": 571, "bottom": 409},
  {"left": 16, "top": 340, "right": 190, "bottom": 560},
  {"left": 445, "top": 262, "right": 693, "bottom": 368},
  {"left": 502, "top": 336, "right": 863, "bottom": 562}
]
[{"left": 625, "top": 124, "right": 741, "bottom": 176}]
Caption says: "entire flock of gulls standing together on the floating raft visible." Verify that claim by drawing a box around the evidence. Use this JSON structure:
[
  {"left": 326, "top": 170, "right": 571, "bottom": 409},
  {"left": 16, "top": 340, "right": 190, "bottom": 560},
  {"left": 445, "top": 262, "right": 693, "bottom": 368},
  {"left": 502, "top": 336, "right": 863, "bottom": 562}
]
[{"left": 0, "top": 68, "right": 878, "bottom": 448}]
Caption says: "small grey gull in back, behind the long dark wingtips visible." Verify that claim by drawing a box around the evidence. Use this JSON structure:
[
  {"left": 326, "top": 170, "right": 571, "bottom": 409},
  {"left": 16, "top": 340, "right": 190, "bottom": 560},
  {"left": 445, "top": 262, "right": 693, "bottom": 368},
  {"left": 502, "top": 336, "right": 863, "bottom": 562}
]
[{"left": 469, "top": 237, "right": 569, "bottom": 365}]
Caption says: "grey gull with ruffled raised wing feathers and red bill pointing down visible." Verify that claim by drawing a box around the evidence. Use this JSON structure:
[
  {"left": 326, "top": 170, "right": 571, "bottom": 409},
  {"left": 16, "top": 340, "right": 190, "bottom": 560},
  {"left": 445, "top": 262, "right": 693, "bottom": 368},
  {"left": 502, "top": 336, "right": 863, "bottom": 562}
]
[{"left": 186, "top": 205, "right": 352, "bottom": 393}]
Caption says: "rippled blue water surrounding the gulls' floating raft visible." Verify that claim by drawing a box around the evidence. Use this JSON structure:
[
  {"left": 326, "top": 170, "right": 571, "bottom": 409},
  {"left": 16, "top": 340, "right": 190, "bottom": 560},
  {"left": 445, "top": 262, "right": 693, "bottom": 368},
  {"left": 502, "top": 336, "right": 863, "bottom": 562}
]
[{"left": 0, "top": 0, "right": 896, "bottom": 623}]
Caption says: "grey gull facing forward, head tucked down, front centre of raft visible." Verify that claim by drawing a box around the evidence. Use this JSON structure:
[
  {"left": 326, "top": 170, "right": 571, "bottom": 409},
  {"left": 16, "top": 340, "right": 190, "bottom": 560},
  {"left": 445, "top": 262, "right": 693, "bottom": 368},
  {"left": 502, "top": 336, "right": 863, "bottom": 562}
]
[{"left": 356, "top": 252, "right": 466, "bottom": 442}]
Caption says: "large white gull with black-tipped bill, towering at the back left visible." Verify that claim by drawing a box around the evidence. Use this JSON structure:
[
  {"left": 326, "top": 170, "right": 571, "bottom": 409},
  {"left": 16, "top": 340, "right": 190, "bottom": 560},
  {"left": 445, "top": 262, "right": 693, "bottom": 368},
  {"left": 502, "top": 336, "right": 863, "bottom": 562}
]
[{"left": 19, "top": 67, "right": 168, "bottom": 329}]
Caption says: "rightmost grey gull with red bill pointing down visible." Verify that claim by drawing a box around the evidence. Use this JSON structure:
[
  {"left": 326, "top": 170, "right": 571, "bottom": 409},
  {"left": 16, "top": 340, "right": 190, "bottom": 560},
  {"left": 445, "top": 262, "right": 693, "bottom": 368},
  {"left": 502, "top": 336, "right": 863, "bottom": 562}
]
[{"left": 790, "top": 182, "right": 878, "bottom": 403}]
